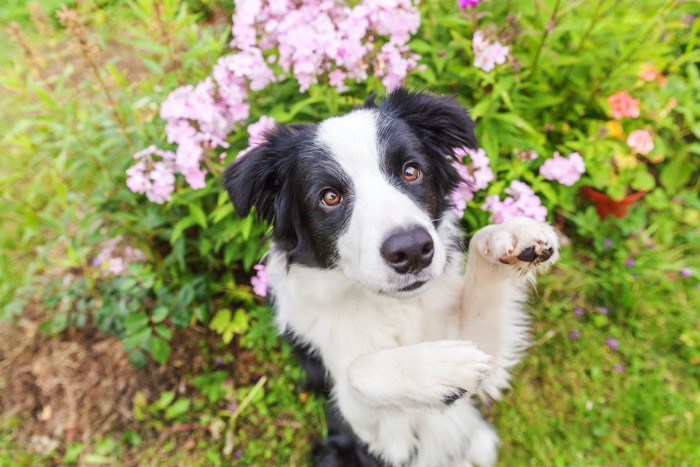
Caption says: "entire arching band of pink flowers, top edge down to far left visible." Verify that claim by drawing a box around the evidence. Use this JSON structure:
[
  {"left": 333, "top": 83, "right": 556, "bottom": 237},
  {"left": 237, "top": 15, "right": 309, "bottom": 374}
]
[{"left": 127, "top": 0, "right": 420, "bottom": 203}]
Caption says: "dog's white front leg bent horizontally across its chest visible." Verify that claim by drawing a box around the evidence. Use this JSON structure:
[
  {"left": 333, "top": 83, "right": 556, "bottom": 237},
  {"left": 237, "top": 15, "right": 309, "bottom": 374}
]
[{"left": 333, "top": 340, "right": 491, "bottom": 465}]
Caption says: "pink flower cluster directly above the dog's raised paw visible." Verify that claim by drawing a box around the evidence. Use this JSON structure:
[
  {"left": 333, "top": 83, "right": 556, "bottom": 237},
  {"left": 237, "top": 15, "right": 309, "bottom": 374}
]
[{"left": 482, "top": 180, "right": 547, "bottom": 224}]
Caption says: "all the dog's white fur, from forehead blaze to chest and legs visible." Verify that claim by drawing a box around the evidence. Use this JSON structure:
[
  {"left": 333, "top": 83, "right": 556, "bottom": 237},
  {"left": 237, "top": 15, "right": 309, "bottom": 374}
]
[{"left": 268, "top": 110, "right": 558, "bottom": 467}]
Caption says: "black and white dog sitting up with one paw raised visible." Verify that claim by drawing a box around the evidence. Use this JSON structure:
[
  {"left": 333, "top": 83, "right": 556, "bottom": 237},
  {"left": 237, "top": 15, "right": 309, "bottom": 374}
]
[{"left": 224, "top": 89, "right": 558, "bottom": 467}]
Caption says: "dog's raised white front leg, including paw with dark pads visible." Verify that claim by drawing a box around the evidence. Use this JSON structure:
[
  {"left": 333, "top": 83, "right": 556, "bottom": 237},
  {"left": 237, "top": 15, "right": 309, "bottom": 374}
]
[{"left": 462, "top": 217, "right": 559, "bottom": 399}]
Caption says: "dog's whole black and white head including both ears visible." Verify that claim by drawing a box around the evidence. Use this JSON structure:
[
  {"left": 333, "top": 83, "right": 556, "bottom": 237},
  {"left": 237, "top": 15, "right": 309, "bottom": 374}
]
[{"left": 224, "top": 90, "right": 475, "bottom": 297}]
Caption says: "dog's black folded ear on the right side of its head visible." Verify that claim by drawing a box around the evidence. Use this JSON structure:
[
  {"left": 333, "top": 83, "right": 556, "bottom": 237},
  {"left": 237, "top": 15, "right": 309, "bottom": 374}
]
[{"left": 382, "top": 88, "right": 477, "bottom": 155}]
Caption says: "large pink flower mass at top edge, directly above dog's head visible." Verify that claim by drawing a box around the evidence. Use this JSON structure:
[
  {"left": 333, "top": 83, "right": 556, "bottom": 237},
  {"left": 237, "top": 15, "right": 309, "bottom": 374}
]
[{"left": 231, "top": 0, "right": 420, "bottom": 92}]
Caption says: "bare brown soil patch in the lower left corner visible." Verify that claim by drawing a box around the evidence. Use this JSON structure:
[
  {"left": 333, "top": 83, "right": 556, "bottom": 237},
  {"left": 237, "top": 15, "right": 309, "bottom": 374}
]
[{"left": 0, "top": 308, "right": 220, "bottom": 455}]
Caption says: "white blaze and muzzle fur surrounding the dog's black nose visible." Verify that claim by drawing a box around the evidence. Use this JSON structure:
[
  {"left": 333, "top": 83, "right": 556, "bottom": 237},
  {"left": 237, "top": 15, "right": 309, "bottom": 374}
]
[{"left": 316, "top": 109, "right": 446, "bottom": 291}]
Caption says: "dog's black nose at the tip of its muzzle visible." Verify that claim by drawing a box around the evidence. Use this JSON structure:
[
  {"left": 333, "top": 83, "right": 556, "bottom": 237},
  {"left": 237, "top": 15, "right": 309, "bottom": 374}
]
[{"left": 380, "top": 227, "right": 434, "bottom": 274}]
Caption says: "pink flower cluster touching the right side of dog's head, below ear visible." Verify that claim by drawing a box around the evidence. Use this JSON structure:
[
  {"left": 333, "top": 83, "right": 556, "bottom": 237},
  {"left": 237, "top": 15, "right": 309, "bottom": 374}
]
[{"left": 450, "top": 147, "right": 493, "bottom": 216}]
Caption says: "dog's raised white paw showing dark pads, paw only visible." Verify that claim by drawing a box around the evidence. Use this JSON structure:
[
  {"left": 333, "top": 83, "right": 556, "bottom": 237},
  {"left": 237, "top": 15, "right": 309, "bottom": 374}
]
[{"left": 469, "top": 217, "right": 559, "bottom": 274}]
